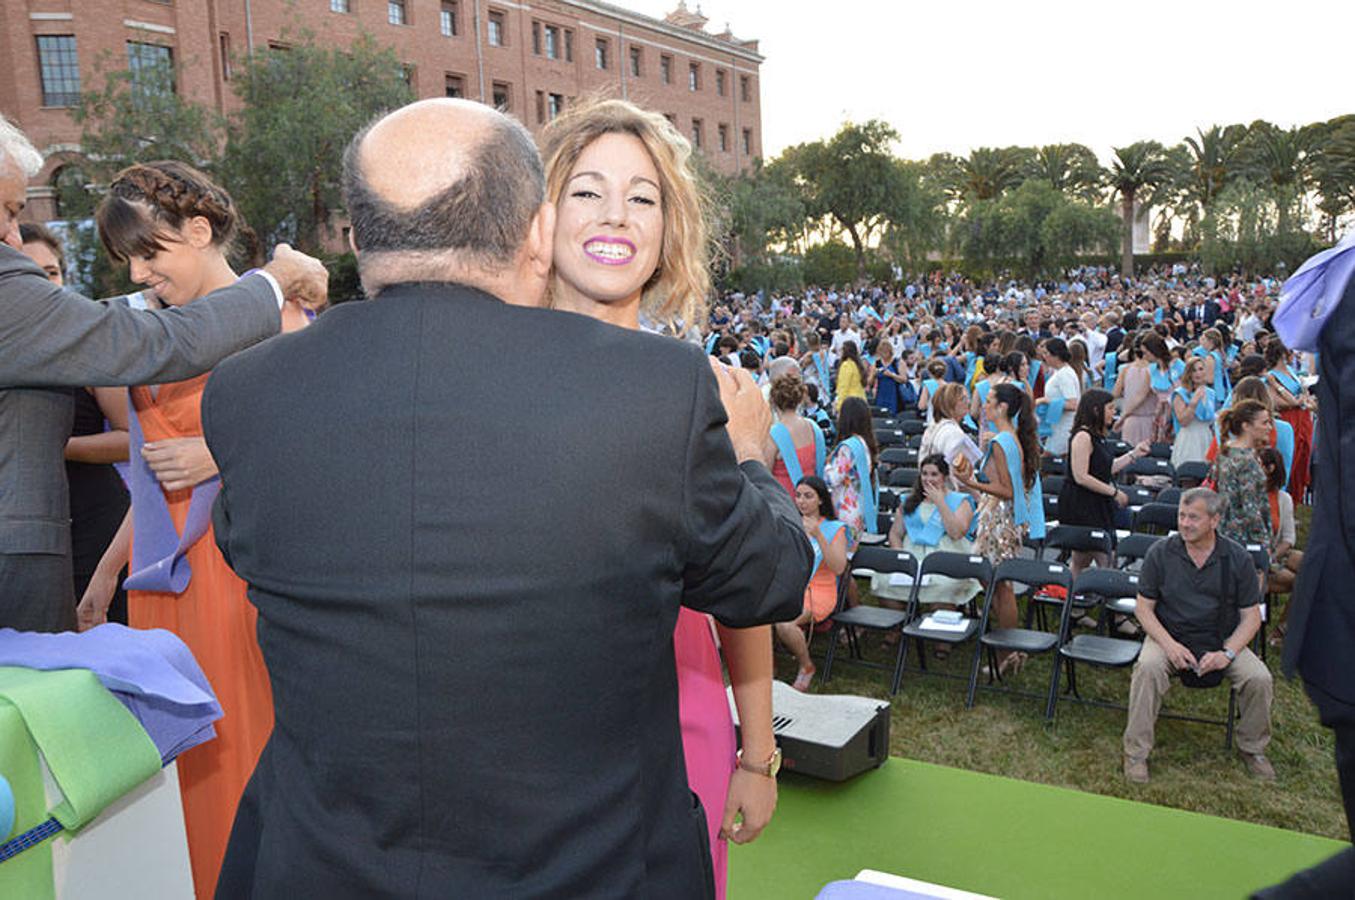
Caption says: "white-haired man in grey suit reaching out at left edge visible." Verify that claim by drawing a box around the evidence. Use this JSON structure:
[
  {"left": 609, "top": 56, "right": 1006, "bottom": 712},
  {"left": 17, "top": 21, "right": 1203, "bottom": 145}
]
[{"left": 0, "top": 117, "right": 328, "bottom": 632}]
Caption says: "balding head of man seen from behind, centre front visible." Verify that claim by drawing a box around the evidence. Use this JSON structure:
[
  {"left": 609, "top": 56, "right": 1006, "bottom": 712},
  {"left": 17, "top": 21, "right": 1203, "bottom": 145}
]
[{"left": 344, "top": 99, "right": 545, "bottom": 281}]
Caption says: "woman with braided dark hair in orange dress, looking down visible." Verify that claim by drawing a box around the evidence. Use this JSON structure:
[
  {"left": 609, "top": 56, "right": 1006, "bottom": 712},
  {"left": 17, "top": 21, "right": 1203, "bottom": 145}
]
[{"left": 80, "top": 163, "right": 306, "bottom": 897}]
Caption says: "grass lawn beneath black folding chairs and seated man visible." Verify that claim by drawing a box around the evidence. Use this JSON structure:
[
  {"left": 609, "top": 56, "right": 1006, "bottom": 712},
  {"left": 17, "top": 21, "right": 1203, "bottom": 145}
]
[{"left": 776, "top": 508, "right": 1350, "bottom": 840}]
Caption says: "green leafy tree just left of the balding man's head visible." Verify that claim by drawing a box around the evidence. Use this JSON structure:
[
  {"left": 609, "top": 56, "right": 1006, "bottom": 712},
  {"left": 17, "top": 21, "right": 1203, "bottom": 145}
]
[{"left": 224, "top": 34, "right": 413, "bottom": 252}]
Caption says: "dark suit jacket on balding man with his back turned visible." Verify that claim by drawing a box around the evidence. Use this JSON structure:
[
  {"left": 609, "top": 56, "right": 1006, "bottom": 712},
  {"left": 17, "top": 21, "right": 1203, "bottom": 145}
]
[{"left": 203, "top": 285, "right": 812, "bottom": 900}]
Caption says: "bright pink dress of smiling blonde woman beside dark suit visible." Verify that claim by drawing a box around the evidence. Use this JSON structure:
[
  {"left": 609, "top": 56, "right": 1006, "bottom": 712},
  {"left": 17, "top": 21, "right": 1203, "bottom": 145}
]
[{"left": 673, "top": 607, "right": 737, "bottom": 900}]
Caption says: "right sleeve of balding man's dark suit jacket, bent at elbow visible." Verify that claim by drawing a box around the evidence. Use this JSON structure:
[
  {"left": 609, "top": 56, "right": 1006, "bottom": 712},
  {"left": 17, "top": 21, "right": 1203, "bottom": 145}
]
[{"left": 683, "top": 356, "right": 813, "bottom": 628}]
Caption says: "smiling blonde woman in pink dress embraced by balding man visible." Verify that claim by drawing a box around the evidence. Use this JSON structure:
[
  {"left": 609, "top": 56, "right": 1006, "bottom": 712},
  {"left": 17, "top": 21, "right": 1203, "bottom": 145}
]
[{"left": 541, "top": 94, "right": 776, "bottom": 897}]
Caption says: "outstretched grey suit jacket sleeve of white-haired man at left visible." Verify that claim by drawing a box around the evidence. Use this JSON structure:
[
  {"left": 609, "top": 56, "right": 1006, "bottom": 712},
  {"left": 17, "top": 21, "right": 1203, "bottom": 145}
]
[{"left": 0, "top": 247, "right": 280, "bottom": 388}]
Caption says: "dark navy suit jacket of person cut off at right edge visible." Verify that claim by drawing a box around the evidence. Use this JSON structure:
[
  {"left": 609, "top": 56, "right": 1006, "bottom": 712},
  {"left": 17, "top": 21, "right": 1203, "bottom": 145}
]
[{"left": 1285, "top": 271, "right": 1355, "bottom": 718}]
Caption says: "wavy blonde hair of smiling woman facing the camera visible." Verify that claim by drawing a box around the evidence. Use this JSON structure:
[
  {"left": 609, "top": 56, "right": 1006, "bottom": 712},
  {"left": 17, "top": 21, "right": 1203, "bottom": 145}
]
[{"left": 539, "top": 99, "right": 710, "bottom": 328}]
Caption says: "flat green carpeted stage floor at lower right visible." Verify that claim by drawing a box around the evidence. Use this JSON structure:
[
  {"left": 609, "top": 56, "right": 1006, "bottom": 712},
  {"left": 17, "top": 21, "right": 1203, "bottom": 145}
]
[{"left": 729, "top": 758, "right": 1346, "bottom": 900}]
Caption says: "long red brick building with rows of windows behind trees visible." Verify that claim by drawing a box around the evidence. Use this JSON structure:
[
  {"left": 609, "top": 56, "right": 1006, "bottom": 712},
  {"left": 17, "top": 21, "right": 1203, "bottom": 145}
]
[{"left": 0, "top": 0, "right": 763, "bottom": 220}]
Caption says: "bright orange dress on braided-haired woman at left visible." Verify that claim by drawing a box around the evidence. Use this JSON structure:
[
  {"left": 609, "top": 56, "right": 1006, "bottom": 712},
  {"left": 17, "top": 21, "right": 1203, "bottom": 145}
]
[{"left": 127, "top": 375, "right": 272, "bottom": 897}]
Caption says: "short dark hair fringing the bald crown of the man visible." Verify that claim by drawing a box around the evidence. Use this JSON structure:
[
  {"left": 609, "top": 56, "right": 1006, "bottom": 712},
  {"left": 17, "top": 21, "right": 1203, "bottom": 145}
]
[{"left": 343, "top": 117, "right": 546, "bottom": 267}]
